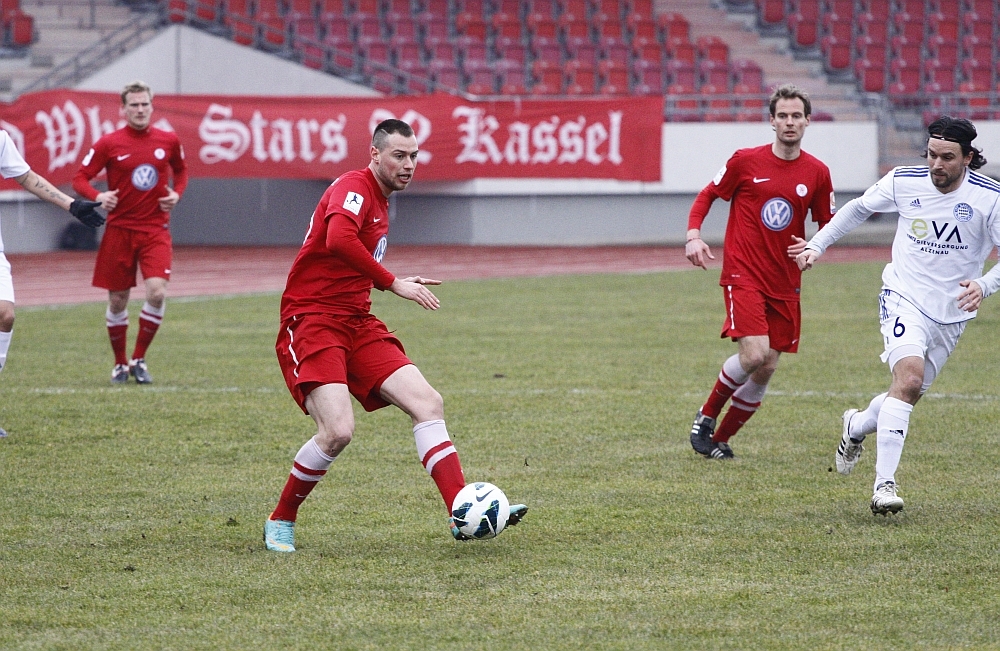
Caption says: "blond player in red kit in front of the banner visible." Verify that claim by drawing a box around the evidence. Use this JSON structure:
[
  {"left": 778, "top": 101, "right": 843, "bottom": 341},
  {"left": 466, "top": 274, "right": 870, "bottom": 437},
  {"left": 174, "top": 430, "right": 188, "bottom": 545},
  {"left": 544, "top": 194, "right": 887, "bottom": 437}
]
[{"left": 73, "top": 81, "right": 188, "bottom": 384}]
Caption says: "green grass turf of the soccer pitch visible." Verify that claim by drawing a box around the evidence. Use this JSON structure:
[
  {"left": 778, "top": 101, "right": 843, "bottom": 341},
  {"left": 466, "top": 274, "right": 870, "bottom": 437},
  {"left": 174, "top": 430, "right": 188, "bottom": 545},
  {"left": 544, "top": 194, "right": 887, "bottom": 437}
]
[{"left": 0, "top": 264, "right": 1000, "bottom": 650}]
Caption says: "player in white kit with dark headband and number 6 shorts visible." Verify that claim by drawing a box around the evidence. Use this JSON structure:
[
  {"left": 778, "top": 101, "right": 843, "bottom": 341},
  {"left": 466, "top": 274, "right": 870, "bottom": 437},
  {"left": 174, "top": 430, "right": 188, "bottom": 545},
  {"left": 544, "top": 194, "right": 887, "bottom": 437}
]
[{"left": 796, "top": 116, "right": 1000, "bottom": 515}]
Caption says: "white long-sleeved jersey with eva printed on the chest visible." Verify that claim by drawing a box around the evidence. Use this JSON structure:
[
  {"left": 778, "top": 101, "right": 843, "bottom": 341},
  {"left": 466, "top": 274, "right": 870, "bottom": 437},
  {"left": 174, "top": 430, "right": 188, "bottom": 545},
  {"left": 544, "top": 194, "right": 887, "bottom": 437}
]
[{"left": 809, "top": 166, "right": 1000, "bottom": 323}]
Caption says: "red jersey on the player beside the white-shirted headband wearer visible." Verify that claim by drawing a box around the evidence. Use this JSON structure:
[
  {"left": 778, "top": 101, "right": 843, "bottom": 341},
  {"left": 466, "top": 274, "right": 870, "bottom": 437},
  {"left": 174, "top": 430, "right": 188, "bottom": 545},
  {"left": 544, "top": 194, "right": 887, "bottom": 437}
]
[{"left": 688, "top": 145, "right": 836, "bottom": 300}]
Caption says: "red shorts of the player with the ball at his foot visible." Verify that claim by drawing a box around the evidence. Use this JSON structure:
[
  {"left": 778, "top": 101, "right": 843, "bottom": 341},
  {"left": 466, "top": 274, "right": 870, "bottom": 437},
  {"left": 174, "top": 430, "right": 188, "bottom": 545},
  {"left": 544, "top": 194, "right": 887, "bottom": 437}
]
[{"left": 274, "top": 314, "right": 413, "bottom": 414}]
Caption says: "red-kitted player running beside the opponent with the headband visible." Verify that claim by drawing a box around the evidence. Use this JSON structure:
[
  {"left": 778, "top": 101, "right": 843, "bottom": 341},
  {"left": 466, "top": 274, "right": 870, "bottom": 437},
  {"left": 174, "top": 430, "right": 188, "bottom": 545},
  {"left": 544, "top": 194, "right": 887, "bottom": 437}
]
[{"left": 684, "top": 85, "right": 836, "bottom": 459}]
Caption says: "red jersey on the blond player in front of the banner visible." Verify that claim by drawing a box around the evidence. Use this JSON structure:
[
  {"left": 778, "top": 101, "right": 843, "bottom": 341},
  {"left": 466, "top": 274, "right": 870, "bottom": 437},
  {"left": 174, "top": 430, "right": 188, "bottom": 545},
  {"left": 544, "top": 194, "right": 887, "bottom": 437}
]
[{"left": 73, "top": 126, "right": 187, "bottom": 232}]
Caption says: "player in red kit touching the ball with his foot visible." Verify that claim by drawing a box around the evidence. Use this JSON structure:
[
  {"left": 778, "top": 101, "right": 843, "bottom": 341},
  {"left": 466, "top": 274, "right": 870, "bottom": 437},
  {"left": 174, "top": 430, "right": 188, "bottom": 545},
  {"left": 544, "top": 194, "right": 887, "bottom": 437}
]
[{"left": 264, "top": 120, "right": 527, "bottom": 552}]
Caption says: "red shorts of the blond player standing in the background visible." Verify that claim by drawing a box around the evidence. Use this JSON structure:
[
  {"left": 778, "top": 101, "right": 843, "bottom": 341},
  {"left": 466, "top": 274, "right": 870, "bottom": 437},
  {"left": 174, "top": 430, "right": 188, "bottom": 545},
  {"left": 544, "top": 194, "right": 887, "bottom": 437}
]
[{"left": 91, "top": 226, "right": 173, "bottom": 292}]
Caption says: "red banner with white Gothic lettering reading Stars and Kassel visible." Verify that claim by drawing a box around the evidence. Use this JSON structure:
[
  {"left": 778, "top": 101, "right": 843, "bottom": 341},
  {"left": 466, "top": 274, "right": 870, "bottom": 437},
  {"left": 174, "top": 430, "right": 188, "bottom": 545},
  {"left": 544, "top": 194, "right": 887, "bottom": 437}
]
[{"left": 0, "top": 90, "right": 663, "bottom": 189}]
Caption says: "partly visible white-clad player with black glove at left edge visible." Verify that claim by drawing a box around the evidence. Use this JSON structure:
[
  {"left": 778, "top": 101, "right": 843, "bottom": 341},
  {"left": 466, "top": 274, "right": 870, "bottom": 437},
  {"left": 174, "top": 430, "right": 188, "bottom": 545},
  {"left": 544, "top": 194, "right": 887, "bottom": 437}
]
[{"left": 0, "top": 130, "right": 104, "bottom": 438}]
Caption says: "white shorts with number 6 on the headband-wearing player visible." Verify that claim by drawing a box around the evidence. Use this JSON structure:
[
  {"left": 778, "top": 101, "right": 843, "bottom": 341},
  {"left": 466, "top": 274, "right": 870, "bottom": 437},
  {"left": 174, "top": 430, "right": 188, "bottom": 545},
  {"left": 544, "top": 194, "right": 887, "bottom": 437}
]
[{"left": 878, "top": 289, "right": 967, "bottom": 393}]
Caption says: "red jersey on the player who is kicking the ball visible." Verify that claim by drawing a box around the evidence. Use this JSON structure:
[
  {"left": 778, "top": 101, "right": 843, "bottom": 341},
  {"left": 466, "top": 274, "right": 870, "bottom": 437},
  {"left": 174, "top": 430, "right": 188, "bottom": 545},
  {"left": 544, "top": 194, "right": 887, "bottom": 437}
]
[{"left": 281, "top": 168, "right": 396, "bottom": 321}]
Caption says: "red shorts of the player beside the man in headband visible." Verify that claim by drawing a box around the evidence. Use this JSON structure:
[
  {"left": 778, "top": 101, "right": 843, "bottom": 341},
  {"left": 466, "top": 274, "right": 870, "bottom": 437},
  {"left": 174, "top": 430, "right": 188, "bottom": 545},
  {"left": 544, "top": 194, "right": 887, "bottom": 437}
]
[{"left": 722, "top": 285, "right": 802, "bottom": 353}]
